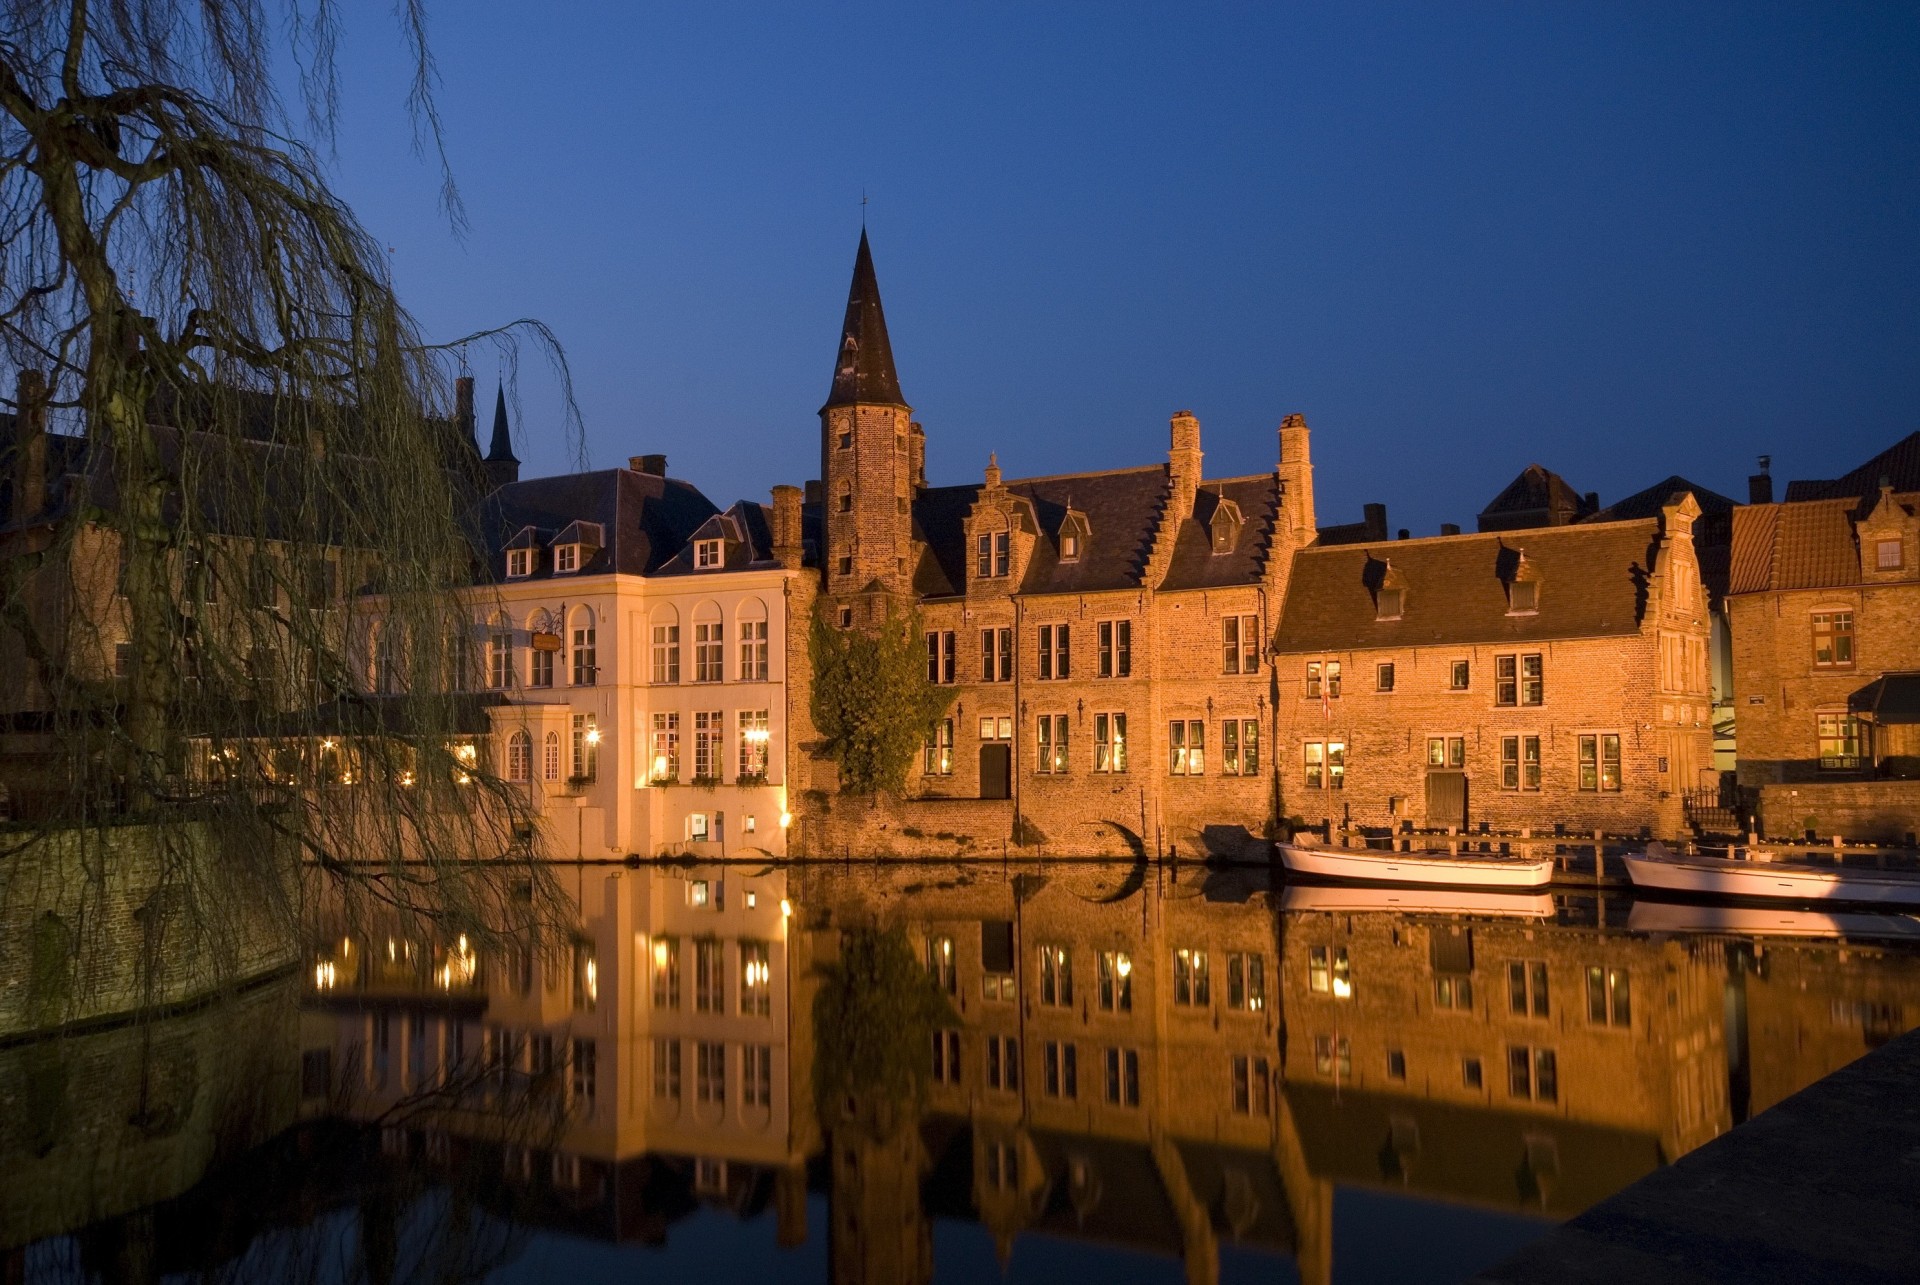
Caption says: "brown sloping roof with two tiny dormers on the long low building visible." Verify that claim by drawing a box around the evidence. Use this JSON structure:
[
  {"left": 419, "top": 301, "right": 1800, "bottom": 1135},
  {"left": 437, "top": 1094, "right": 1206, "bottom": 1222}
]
[{"left": 1277, "top": 519, "right": 1659, "bottom": 651}]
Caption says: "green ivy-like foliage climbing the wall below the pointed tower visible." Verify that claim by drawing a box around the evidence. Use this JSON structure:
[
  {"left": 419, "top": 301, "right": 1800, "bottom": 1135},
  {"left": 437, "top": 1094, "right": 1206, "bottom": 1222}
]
[{"left": 810, "top": 607, "right": 952, "bottom": 793}]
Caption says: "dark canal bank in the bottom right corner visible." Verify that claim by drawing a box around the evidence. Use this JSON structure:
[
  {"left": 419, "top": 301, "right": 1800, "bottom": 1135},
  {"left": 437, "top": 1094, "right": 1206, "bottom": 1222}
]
[{"left": 1475, "top": 1031, "right": 1920, "bottom": 1285}]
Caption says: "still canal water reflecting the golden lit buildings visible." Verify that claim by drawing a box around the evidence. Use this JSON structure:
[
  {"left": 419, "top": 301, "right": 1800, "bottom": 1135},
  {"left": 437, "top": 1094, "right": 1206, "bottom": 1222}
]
[{"left": 0, "top": 862, "right": 1920, "bottom": 1285}]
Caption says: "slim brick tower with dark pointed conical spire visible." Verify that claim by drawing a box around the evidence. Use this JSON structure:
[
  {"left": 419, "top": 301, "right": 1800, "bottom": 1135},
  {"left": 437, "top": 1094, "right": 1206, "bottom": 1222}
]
[{"left": 820, "top": 230, "right": 914, "bottom": 603}]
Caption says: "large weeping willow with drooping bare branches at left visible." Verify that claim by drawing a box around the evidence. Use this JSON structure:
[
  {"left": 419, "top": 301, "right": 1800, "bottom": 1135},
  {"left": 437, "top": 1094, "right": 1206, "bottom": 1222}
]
[{"left": 0, "top": 0, "right": 574, "bottom": 1021}]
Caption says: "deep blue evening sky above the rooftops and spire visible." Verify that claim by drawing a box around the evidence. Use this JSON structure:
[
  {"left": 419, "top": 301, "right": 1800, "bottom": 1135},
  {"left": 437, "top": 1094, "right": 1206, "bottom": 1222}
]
[{"left": 322, "top": 0, "right": 1920, "bottom": 534}]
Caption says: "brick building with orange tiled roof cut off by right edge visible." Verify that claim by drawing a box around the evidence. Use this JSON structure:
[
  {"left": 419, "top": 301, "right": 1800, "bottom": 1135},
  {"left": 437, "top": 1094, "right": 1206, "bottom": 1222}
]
[{"left": 1730, "top": 432, "right": 1920, "bottom": 841}]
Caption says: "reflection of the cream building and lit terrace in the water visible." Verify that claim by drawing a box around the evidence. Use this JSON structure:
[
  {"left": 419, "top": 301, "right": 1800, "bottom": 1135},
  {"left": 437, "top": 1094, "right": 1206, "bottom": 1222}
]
[{"left": 305, "top": 866, "right": 812, "bottom": 1239}]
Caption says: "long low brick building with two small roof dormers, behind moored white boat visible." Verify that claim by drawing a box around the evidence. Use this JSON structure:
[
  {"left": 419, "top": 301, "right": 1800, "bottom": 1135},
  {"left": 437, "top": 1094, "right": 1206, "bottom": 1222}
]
[{"left": 1273, "top": 492, "right": 1713, "bottom": 834}]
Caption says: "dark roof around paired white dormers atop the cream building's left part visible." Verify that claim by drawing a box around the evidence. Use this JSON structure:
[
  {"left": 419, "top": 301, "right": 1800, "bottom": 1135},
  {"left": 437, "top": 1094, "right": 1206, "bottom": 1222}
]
[{"left": 470, "top": 469, "right": 718, "bottom": 580}]
